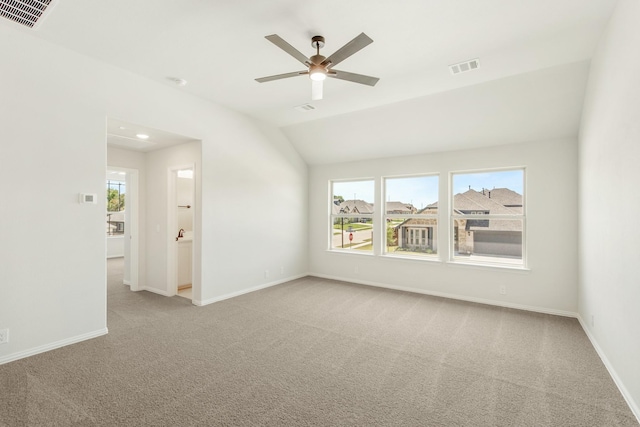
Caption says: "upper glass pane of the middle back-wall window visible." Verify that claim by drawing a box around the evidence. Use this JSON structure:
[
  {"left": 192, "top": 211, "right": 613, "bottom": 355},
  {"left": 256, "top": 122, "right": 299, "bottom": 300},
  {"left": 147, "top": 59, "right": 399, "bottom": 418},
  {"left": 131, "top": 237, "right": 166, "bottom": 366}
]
[{"left": 385, "top": 176, "right": 438, "bottom": 215}]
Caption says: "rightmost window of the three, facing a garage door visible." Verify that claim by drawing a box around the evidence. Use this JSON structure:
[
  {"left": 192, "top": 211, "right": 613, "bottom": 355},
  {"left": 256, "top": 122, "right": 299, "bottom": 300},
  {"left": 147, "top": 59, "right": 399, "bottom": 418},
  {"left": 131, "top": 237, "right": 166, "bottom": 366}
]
[{"left": 451, "top": 169, "right": 525, "bottom": 266}]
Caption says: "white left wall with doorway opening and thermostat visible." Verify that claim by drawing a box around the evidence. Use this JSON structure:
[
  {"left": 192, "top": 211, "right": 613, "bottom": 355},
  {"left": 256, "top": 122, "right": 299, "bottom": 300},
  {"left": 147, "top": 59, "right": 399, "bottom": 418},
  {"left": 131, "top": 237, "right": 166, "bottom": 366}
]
[{"left": 0, "top": 25, "right": 307, "bottom": 363}]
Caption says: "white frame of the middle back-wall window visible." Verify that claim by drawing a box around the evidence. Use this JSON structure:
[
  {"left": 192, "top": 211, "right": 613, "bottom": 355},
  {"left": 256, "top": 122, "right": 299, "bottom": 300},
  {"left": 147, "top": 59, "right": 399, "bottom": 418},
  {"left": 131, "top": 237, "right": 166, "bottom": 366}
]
[{"left": 381, "top": 173, "right": 440, "bottom": 261}]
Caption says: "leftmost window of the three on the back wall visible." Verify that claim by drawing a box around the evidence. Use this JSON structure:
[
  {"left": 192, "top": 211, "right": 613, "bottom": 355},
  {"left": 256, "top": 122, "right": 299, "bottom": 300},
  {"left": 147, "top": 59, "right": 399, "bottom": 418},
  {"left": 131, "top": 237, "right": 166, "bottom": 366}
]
[{"left": 330, "top": 180, "right": 375, "bottom": 253}]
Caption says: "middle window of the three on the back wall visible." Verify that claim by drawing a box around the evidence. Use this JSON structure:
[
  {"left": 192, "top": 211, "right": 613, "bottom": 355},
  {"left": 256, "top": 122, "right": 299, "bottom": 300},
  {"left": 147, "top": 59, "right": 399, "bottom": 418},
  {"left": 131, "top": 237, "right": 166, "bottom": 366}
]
[{"left": 384, "top": 175, "right": 438, "bottom": 256}]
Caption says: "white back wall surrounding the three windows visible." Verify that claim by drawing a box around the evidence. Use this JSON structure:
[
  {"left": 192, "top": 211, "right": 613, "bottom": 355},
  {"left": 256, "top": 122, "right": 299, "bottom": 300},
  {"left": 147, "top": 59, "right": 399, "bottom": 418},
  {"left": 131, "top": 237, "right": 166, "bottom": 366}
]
[{"left": 309, "top": 139, "right": 578, "bottom": 314}]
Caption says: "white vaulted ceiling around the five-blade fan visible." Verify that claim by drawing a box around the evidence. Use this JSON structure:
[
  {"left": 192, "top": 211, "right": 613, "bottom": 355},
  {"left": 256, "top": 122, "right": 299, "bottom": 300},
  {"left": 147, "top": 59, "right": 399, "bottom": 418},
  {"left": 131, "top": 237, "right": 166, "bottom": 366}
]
[{"left": 12, "top": 0, "right": 616, "bottom": 163}]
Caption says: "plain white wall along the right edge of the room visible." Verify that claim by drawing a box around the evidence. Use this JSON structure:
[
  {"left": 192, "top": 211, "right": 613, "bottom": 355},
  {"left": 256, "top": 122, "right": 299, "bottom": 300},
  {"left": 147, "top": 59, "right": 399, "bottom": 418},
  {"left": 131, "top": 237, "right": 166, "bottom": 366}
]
[{"left": 579, "top": 0, "right": 640, "bottom": 418}]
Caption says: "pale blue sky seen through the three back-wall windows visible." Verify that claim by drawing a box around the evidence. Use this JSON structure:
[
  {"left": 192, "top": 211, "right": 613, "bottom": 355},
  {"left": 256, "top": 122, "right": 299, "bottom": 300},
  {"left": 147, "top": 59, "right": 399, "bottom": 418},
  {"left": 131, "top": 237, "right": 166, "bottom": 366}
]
[{"left": 333, "top": 169, "right": 524, "bottom": 209}]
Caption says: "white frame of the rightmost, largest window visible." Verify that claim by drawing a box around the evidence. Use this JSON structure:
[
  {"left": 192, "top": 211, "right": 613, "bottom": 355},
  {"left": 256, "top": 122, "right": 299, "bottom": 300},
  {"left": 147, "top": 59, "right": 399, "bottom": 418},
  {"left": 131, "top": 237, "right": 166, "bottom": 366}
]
[{"left": 448, "top": 166, "right": 527, "bottom": 269}]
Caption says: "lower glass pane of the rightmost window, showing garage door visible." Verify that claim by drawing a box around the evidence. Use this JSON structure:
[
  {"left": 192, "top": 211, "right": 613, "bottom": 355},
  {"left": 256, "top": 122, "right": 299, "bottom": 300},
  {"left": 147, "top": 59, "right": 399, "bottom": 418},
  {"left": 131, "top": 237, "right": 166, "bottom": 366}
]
[{"left": 453, "top": 218, "right": 523, "bottom": 264}]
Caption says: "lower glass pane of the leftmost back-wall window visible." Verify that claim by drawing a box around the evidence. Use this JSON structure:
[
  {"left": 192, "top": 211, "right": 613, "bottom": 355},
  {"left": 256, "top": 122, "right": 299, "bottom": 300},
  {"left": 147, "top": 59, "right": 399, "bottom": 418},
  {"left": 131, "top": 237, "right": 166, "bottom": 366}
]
[{"left": 331, "top": 216, "right": 373, "bottom": 252}]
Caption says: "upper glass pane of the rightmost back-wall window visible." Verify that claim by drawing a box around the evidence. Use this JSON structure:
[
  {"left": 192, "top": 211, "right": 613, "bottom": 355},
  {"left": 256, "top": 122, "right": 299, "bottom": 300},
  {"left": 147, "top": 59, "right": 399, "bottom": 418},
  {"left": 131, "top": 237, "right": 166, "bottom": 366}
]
[{"left": 453, "top": 169, "right": 524, "bottom": 215}]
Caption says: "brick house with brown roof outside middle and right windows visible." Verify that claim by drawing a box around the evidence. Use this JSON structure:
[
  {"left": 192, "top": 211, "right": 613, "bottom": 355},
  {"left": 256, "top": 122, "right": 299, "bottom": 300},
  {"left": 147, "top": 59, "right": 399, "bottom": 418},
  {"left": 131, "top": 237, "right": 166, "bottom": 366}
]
[{"left": 402, "top": 188, "right": 523, "bottom": 257}]
